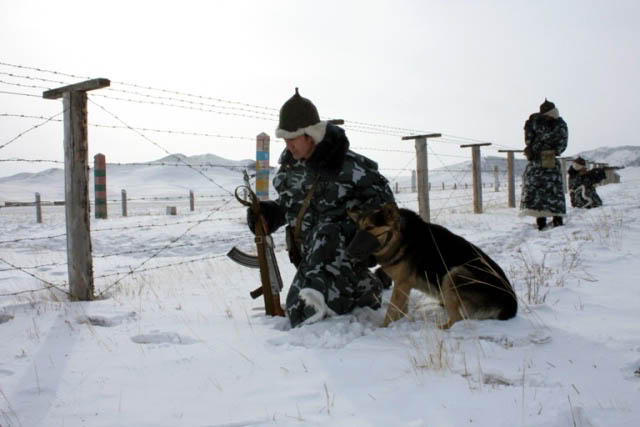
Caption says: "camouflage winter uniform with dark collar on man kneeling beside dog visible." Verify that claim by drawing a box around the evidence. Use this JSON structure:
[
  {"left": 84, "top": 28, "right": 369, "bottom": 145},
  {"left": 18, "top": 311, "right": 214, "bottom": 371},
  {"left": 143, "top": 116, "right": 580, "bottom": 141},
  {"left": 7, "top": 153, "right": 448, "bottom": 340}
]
[{"left": 273, "top": 124, "right": 394, "bottom": 326}]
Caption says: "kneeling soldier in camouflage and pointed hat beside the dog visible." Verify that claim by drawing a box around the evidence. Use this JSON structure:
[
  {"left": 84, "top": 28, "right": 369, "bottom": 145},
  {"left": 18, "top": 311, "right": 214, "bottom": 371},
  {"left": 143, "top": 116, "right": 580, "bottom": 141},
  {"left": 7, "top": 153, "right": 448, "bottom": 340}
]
[{"left": 247, "top": 88, "right": 394, "bottom": 327}]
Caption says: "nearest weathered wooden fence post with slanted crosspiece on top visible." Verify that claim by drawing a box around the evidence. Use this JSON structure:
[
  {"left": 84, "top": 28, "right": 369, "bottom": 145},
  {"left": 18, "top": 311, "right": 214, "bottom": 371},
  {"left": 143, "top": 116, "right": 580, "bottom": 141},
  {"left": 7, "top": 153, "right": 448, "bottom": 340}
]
[{"left": 42, "top": 79, "right": 111, "bottom": 301}]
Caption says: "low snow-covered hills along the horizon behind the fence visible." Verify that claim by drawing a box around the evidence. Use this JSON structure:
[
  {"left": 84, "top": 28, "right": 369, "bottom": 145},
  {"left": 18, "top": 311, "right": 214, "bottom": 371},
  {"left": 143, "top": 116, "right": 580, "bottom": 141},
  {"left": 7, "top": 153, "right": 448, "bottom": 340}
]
[{"left": 0, "top": 146, "right": 640, "bottom": 205}]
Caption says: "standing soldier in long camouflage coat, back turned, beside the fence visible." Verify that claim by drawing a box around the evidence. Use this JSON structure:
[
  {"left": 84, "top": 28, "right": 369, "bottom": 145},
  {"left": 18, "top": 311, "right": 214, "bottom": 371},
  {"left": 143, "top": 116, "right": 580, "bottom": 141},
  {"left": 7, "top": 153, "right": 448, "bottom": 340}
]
[{"left": 520, "top": 99, "right": 569, "bottom": 230}]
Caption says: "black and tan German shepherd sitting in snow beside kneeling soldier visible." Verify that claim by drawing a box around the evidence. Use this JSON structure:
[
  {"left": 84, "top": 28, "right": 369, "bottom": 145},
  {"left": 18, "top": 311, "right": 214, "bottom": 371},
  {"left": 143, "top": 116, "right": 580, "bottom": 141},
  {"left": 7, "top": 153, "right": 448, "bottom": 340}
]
[{"left": 347, "top": 204, "right": 518, "bottom": 329}]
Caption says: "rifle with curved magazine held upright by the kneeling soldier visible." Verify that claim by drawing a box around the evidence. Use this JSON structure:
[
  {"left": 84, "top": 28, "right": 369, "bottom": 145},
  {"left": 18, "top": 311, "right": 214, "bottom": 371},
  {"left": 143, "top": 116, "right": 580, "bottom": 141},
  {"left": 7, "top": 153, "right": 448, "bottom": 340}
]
[{"left": 227, "top": 185, "right": 284, "bottom": 316}]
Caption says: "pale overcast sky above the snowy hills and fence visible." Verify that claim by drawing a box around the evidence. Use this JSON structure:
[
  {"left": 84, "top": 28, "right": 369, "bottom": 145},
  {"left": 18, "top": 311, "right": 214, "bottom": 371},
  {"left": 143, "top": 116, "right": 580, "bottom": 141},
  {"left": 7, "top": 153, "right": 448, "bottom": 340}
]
[{"left": 0, "top": 0, "right": 640, "bottom": 176}]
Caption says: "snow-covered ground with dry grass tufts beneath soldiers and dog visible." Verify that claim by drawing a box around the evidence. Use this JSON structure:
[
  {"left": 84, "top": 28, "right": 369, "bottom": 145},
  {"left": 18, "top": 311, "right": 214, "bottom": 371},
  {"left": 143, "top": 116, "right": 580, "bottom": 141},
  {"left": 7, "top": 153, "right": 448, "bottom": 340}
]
[{"left": 0, "top": 167, "right": 640, "bottom": 427}]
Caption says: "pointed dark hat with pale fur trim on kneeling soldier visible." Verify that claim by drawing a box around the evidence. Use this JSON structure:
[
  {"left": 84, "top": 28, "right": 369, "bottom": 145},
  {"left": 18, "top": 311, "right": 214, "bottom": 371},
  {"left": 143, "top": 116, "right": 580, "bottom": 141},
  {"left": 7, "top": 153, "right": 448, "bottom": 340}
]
[{"left": 276, "top": 88, "right": 327, "bottom": 143}]
